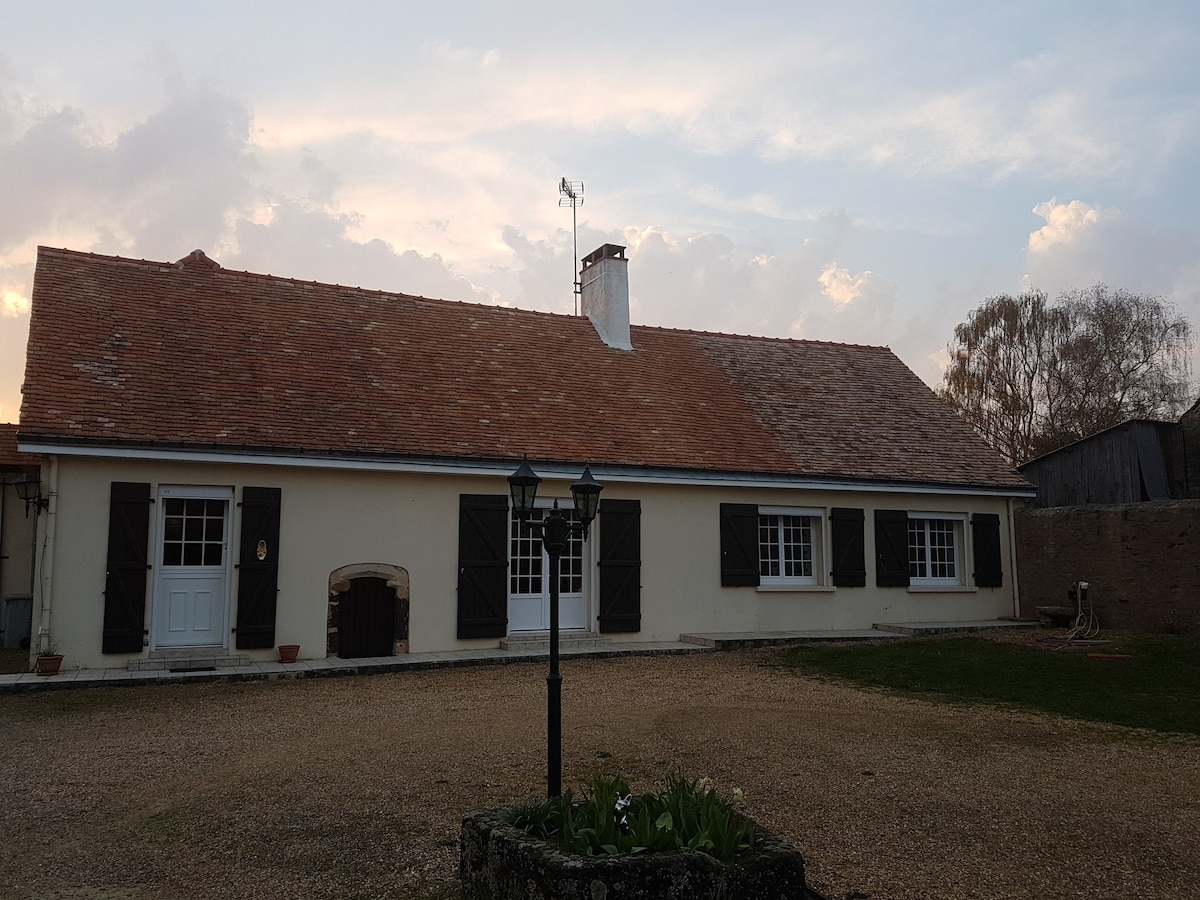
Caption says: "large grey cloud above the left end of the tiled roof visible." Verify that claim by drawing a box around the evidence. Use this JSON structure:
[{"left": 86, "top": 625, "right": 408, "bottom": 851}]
[{"left": 0, "top": 82, "right": 254, "bottom": 258}]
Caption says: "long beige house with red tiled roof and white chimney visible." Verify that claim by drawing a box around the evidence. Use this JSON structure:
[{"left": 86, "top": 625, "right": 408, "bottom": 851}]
[{"left": 19, "top": 245, "right": 1032, "bottom": 667}]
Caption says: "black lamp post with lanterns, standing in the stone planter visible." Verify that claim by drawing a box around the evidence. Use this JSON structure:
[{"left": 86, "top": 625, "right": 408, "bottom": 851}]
[{"left": 509, "top": 458, "right": 604, "bottom": 797}]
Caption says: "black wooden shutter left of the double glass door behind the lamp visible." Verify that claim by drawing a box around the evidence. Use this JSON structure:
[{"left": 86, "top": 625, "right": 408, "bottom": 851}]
[{"left": 458, "top": 493, "right": 509, "bottom": 638}]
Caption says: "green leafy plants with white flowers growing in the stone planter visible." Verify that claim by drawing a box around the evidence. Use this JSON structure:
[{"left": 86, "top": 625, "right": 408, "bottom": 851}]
[{"left": 511, "top": 775, "right": 758, "bottom": 862}]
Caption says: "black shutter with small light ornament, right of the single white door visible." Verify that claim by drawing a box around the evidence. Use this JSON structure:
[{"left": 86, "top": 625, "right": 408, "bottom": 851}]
[{"left": 236, "top": 487, "right": 282, "bottom": 650}]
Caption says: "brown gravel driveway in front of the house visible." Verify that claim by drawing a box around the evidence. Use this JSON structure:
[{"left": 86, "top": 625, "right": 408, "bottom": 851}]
[{"left": 0, "top": 650, "right": 1200, "bottom": 900}]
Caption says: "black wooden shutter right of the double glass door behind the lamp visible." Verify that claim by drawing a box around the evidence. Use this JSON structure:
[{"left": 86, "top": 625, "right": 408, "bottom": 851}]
[{"left": 598, "top": 500, "right": 642, "bottom": 632}]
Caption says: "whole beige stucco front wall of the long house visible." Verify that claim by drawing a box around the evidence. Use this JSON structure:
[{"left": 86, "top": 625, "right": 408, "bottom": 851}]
[{"left": 35, "top": 457, "right": 1013, "bottom": 667}]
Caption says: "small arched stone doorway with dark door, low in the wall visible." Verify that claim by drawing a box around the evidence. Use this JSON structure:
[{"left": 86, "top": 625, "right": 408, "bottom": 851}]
[{"left": 325, "top": 563, "right": 408, "bottom": 659}]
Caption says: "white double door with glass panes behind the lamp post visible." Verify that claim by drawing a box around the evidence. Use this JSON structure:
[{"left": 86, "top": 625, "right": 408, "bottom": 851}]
[{"left": 509, "top": 500, "right": 588, "bottom": 631}]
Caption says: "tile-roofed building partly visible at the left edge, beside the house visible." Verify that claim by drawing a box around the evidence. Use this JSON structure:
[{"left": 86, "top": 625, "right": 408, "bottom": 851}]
[{"left": 0, "top": 424, "right": 41, "bottom": 649}]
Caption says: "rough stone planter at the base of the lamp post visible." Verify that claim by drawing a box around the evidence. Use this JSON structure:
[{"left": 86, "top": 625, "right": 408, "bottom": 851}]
[{"left": 458, "top": 810, "right": 811, "bottom": 900}]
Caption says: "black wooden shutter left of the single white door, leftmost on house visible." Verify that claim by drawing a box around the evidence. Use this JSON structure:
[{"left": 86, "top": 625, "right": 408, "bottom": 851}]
[{"left": 101, "top": 481, "right": 150, "bottom": 653}]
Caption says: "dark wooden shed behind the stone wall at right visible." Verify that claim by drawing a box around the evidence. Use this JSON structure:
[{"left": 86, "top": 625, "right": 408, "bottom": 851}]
[{"left": 1018, "top": 415, "right": 1200, "bottom": 508}]
